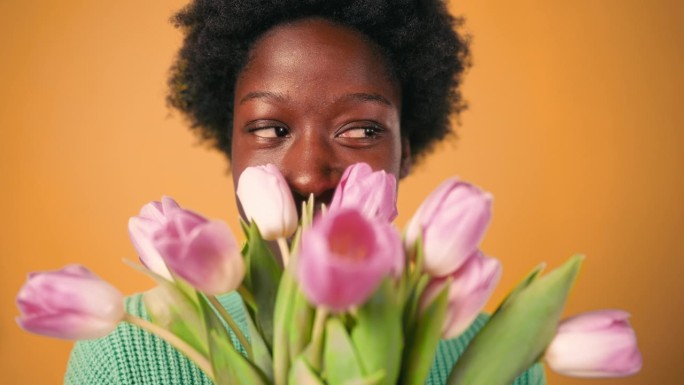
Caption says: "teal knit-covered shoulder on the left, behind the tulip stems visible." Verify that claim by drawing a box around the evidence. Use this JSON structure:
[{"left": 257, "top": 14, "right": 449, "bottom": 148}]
[{"left": 64, "top": 294, "right": 244, "bottom": 385}]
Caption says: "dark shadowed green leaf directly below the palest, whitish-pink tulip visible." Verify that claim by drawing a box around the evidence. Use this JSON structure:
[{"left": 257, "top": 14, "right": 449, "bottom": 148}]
[{"left": 245, "top": 222, "right": 282, "bottom": 349}]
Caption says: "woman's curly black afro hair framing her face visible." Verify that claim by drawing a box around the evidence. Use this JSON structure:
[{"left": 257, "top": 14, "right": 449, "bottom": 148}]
[{"left": 167, "top": 0, "right": 470, "bottom": 160}]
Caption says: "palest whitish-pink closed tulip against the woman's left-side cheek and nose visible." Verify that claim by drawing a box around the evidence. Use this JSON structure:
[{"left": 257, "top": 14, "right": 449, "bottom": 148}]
[{"left": 236, "top": 164, "right": 298, "bottom": 241}]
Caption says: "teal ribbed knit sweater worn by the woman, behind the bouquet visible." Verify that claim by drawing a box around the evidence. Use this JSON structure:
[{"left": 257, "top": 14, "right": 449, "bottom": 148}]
[{"left": 64, "top": 293, "right": 545, "bottom": 385}]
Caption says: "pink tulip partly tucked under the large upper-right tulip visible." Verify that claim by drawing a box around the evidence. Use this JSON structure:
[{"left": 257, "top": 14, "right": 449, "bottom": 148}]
[{"left": 421, "top": 250, "right": 501, "bottom": 339}]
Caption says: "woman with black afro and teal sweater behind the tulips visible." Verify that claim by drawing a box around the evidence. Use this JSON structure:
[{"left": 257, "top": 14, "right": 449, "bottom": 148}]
[{"left": 65, "top": 0, "right": 544, "bottom": 384}]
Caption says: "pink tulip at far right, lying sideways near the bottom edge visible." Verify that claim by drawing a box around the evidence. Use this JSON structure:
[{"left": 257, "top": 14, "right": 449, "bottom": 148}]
[{"left": 545, "top": 310, "right": 642, "bottom": 378}]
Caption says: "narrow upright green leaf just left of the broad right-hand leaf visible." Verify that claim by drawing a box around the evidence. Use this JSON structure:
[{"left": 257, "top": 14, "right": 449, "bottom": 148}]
[{"left": 400, "top": 284, "right": 449, "bottom": 385}]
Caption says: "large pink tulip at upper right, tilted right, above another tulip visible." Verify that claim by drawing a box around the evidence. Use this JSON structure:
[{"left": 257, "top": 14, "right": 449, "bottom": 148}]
[{"left": 406, "top": 178, "right": 492, "bottom": 277}]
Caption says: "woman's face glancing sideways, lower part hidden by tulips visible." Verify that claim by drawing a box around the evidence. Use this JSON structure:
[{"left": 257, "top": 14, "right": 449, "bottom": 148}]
[{"left": 231, "top": 19, "right": 410, "bottom": 206}]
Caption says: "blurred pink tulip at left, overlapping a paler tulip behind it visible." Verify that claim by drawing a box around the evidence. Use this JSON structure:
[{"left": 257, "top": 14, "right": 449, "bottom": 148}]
[{"left": 151, "top": 209, "right": 245, "bottom": 295}]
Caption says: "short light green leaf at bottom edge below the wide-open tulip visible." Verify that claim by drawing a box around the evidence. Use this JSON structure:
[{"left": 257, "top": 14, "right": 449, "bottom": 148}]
[{"left": 323, "top": 317, "right": 363, "bottom": 385}]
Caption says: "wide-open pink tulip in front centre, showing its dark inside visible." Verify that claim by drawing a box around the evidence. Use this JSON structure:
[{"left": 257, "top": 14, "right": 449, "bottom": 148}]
[{"left": 297, "top": 209, "right": 404, "bottom": 311}]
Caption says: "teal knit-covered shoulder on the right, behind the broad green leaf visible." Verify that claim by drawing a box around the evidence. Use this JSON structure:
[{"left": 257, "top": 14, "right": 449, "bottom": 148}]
[{"left": 425, "top": 314, "right": 546, "bottom": 385}]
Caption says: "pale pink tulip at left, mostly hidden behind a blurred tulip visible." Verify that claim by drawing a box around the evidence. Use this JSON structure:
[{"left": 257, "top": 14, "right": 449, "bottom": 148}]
[{"left": 128, "top": 196, "right": 180, "bottom": 280}]
